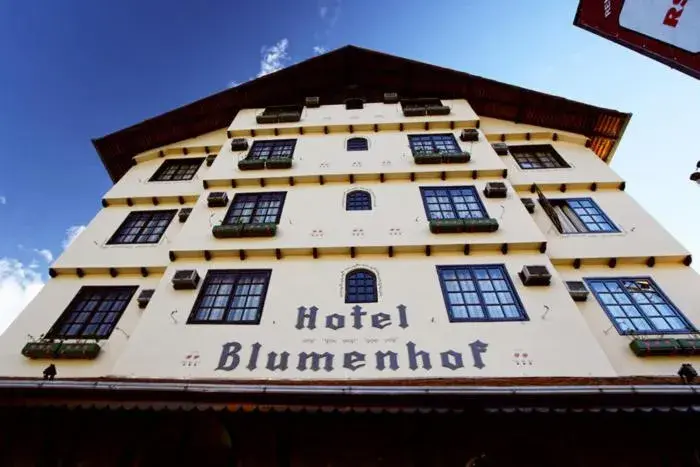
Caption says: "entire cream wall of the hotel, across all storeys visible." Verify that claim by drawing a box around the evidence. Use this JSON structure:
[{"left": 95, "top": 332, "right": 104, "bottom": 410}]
[{"left": 0, "top": 101, "right": 700, "bottom": 380}]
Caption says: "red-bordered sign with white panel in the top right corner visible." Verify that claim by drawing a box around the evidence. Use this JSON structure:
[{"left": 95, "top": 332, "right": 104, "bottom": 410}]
[{"left": 574, "top": 0, "right": 700, "bottom": 79}]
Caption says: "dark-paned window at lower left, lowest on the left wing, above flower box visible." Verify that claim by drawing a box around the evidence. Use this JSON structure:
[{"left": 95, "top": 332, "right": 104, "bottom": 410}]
[{"left": 46, "top": 287, "right": 137, "bottom": 339}]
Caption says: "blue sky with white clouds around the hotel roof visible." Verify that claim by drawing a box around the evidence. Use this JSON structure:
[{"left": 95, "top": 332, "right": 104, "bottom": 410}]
[{"left": 0, "top": 0, "right": 700, "bottom": 332}]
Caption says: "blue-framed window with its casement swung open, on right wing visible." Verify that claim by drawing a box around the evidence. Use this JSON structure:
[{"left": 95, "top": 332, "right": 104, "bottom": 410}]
[{"left": 549, "top": 198, "right": 620, "bottom": 233}]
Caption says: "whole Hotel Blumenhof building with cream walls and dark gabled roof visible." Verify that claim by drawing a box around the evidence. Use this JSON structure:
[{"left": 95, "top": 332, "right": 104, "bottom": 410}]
[{"left": 0, "top": 46, "right": 700, "bottom": 466}]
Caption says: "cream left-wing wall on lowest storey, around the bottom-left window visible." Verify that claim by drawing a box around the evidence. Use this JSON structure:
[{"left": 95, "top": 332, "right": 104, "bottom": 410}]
[{"left": 0, "top": 276, "right": 159, "bottom": 378}]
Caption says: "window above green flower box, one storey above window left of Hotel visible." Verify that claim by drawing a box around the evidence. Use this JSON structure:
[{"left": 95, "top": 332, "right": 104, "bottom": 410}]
[{"left": 223, "top": 191, "right": 287, "bottom": 224}]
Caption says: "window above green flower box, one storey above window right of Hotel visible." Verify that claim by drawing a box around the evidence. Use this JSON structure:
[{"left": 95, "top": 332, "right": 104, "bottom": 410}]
[{"left": 420, "top": 186, "right": 488, "bottom": 220}]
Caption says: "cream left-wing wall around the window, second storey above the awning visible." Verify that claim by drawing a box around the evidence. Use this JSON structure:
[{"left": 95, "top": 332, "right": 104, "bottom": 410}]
[{"left": 53, "top": 203, "right": 191, "bottom": 268}]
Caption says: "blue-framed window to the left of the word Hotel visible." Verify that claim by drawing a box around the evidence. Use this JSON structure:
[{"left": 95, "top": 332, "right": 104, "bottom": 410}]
[{"left": 187, "top": 269, "right": 272, "bottom": 324}]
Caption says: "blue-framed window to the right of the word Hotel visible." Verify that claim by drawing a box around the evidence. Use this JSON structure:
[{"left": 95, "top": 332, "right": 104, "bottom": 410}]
[{"left": 437, "top": 265, "right": 528, "bottom": 322}]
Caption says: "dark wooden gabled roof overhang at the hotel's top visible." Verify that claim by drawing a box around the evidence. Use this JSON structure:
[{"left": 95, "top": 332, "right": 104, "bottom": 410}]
[{"left": 93, "top": 46, "right": 631, "bottom": 182}]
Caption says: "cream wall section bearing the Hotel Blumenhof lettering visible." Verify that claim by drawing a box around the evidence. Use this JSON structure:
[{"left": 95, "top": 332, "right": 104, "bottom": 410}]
[{"left": 112, "top": 255, "right": 614, "bottom": 380}]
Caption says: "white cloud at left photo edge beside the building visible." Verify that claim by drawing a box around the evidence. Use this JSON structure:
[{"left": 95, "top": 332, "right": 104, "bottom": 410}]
[{"left": 0, "top": 258, "right": 44, "bottom": 334}]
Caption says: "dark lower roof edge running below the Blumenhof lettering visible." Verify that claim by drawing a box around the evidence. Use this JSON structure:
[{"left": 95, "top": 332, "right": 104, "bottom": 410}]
[{"left": 0, "top": 377, "right": 700, "bottom": 413}]
